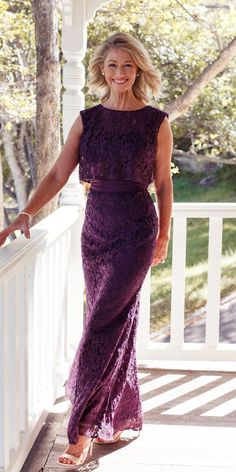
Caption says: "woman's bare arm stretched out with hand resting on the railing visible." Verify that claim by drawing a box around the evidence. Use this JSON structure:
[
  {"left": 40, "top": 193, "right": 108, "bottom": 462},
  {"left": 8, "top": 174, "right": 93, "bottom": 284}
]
[{"left": 0, "top": 115, "right": 83, "bottom": 246}]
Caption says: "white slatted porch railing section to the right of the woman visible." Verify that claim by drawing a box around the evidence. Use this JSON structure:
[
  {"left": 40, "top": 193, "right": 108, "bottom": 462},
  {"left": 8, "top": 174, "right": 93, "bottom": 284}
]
[{"left": 137, "top": 203, "right": 236, "bottom": 369}]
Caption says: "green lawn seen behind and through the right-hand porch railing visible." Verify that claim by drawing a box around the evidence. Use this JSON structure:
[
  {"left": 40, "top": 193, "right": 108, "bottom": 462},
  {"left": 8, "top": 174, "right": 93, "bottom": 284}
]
[{"left": 151, "top": 172, "right": 236, "bottom": 331}]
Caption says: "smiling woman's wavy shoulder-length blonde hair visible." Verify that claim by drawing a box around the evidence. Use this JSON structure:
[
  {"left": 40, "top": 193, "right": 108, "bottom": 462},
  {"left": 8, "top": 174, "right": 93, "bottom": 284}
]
[{"left": 88, "top": 33, "right": 161, "bottom": 102}]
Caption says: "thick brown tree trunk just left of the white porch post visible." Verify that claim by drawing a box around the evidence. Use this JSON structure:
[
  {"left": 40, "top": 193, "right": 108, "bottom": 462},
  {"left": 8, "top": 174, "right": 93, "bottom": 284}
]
[{"left": 33, "top": 0, "right": 61, "bottom": 220}]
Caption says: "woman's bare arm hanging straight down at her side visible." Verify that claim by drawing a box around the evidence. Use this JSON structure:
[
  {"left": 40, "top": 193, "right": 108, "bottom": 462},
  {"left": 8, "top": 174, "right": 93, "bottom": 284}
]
[{"left": 152, "top": 118, "right": 173, "bottom": 265}]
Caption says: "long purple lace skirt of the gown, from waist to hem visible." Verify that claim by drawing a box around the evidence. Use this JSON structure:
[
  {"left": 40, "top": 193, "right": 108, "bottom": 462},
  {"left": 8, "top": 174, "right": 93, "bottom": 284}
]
[{"left": 66, "top": 181, "right": 158, "bottom": 444}]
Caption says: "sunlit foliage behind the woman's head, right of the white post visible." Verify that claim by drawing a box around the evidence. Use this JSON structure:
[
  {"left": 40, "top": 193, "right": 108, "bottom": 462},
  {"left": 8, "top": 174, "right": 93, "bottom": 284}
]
[{"left": 84, "top": 0, "right": 236, "bottom": 157}]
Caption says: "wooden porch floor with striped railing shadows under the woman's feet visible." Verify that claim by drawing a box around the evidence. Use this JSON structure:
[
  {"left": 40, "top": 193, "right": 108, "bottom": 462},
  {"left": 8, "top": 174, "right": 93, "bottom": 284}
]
[{"left": 21, "top": 368, "right": 236, "bottom": 472}]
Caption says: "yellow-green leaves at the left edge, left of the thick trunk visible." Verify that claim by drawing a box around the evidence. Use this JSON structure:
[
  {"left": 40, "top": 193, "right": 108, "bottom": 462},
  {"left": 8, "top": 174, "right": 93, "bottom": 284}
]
[{"left": 0, "top": 0, "right": 35, "bottom": 122}]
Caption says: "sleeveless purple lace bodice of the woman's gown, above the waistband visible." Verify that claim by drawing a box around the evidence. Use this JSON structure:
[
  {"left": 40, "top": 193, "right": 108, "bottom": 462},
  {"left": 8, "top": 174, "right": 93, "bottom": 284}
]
[{"left": 79, "top": 104, "right": 168, "bottom": 186}]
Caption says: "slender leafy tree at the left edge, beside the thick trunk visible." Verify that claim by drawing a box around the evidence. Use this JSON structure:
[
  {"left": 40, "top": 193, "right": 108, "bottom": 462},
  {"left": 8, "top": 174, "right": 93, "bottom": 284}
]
[{"left": 0, "top": 0, "right": 35, "bottom": 219}]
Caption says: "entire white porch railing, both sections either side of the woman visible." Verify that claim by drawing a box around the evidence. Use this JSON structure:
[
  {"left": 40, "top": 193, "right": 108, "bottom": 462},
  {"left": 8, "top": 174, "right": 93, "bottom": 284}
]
[{"left": 0, "top": 203, "right": 236, "bottom": 472}]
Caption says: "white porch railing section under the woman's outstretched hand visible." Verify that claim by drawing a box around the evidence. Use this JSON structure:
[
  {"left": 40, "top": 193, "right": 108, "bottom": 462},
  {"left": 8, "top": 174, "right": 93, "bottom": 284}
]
[{"left": 0, "top": 206, "right": 84, "bottom": 472}]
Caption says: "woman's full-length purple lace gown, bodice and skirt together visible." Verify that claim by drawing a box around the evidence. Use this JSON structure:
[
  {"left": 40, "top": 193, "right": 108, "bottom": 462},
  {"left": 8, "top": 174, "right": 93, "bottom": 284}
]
[{"left": 66, "top": 104, "right": 168, "bottom": 444}]
